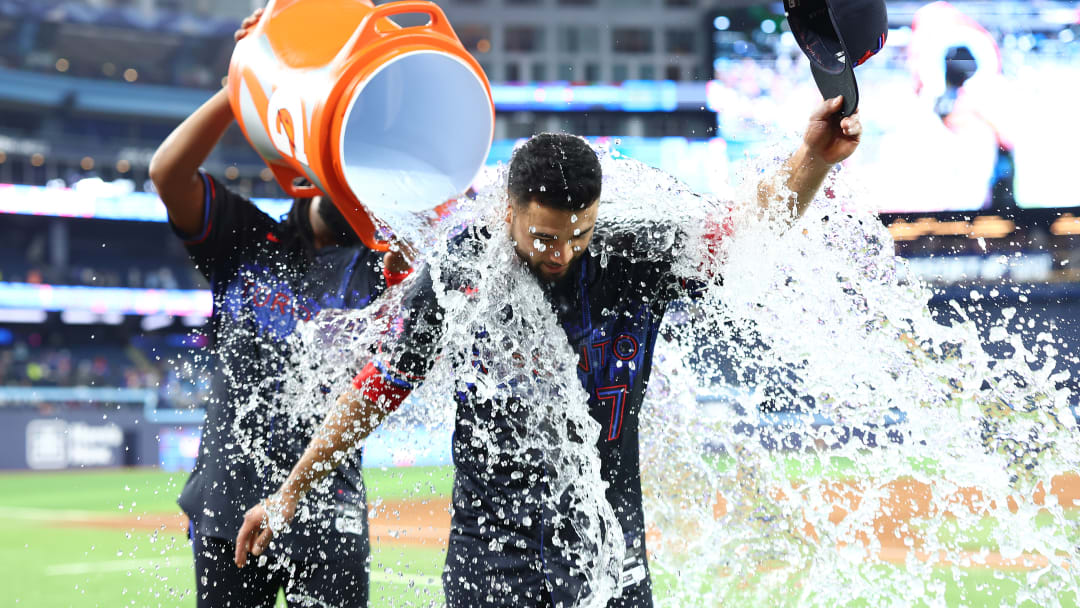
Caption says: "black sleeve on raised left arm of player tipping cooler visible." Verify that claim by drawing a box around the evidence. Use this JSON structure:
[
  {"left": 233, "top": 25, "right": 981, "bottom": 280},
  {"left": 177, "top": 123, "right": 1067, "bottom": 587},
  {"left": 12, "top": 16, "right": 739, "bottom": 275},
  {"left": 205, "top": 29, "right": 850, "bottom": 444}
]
[{"left": 168, "top": 172, "right": 276, "bottom": 279}]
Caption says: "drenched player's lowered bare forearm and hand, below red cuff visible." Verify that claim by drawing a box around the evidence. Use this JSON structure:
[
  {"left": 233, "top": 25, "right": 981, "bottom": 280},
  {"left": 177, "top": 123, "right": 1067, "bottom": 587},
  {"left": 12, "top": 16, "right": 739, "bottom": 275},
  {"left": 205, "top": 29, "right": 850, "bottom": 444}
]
[{"left": 234, "top": 377, "right": 404, "bottom": 568}]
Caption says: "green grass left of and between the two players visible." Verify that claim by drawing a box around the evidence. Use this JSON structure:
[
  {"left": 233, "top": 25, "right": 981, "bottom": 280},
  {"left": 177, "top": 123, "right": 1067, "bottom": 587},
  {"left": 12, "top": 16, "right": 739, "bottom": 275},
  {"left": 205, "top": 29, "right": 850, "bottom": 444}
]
[{"left": 0, "top": 468, "right": 451, "bottom": 608}]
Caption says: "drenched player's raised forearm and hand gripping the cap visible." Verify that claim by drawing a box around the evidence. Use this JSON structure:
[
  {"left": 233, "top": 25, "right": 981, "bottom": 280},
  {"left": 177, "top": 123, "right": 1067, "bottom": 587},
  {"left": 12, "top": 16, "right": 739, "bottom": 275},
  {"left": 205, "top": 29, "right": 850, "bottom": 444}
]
[{"left": 757, "top": 96, "right": 863, "bottom": 223}]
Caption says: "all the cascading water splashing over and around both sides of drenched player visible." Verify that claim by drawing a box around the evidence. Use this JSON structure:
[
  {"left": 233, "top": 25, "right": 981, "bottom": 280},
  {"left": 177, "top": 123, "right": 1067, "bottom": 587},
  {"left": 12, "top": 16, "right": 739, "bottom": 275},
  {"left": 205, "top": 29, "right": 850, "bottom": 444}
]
[{"left": 230, "top": 143, "right": 1080, "bottom": 606}]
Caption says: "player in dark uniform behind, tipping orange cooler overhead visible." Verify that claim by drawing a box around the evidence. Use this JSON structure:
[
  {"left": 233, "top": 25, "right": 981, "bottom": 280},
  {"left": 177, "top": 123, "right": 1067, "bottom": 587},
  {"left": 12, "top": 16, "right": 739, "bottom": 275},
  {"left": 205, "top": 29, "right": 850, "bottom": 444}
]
[{"left": 150, "top": 10, "right": 409, "bottom": 608}]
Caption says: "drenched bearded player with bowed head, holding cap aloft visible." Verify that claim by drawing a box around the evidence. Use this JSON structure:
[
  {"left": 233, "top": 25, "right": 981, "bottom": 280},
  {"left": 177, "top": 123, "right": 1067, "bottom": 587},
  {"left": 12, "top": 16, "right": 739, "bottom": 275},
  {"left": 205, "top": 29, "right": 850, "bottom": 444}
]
[{"left": 235, "top": 91, "right": 862, "bottom": 608}]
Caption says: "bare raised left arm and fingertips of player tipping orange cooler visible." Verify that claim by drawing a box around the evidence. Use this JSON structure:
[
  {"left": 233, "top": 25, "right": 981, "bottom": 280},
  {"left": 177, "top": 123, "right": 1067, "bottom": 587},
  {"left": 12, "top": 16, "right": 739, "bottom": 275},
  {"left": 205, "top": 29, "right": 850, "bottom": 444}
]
[{"left": 150, "top": 9, "right": 262, "bottom": 234}]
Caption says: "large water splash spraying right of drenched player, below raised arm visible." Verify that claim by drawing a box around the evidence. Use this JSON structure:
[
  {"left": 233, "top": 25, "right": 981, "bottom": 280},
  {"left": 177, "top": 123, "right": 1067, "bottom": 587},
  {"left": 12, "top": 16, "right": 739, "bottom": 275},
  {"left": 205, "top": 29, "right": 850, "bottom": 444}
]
[{"left": 643, "top": 151, "right": 1080, "bottom": 606}]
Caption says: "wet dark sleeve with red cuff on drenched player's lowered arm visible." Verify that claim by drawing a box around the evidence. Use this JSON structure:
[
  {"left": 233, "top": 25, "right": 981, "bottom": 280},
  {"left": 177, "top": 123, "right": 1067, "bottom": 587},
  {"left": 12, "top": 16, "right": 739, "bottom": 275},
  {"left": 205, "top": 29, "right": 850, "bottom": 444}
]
[{"left": 352, "top": 270, "right": 443, "bottom": 410}]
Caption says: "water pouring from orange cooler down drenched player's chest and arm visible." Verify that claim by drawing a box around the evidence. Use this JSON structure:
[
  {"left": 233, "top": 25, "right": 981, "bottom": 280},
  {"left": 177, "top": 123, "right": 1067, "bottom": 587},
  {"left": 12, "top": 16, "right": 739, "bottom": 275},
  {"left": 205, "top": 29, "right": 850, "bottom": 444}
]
[{"left": 234, "top": 174, "right": 624, "bottom": 606}]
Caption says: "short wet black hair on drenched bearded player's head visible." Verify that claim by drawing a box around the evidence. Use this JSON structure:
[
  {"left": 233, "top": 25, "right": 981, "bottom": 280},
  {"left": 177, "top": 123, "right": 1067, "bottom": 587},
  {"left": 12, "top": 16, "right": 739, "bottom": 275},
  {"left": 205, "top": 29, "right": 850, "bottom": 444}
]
[{"left": 507, "top": 133, "right": 602, "bottom": 211}]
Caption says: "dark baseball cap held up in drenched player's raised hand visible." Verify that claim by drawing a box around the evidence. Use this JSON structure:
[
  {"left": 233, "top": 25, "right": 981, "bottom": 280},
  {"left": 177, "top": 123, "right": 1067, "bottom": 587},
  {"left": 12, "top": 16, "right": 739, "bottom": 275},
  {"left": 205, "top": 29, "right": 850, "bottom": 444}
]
[{"left": 784, "top": 0, "right": 889, "bottom": 117}]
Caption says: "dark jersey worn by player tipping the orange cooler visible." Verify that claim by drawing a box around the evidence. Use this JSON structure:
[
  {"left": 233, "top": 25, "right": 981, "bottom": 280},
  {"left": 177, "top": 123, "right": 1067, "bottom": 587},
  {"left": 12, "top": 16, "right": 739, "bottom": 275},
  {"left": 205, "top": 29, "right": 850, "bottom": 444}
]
[{"left": 170, "top": 175, "right": 386, "bottom": 562}]
